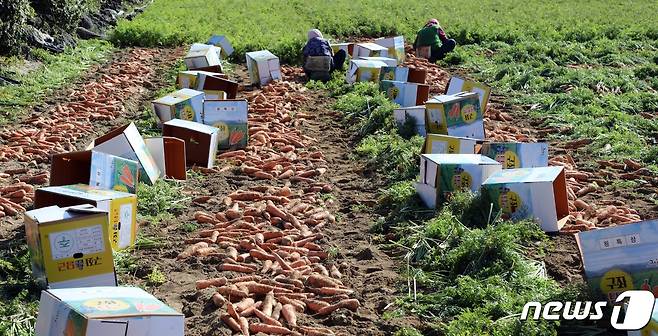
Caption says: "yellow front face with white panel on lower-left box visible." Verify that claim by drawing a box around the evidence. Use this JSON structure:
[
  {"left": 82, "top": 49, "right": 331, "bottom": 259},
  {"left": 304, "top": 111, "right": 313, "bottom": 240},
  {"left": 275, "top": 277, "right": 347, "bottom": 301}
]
[{"left": 39, "top": 216, "right": 114, "bottom": 282}]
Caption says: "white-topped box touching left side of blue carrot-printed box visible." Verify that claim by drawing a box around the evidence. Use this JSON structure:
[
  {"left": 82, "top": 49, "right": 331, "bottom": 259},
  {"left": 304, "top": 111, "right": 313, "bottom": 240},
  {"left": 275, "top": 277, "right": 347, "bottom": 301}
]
[{"left": 151, "top": 88, "right": 204, "bottom": 123}]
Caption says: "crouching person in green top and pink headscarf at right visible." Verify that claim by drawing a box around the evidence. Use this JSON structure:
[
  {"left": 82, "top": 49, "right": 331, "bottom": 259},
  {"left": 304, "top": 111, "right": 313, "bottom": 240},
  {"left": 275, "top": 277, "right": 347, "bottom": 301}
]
[{"left": 414, "top": 19, "right": 457, "bottom": 63}]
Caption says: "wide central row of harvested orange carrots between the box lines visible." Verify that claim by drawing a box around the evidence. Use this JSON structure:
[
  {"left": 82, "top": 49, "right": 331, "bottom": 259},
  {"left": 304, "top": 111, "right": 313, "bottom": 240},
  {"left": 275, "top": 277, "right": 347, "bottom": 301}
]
[{"left": 178, "top": 82, "right": 360, "bottom": 335}]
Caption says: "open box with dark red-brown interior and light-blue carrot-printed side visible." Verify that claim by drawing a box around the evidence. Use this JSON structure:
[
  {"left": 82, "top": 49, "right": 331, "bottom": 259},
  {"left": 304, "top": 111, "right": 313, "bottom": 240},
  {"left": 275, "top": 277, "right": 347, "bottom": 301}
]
[{"left": 50, "top": 151, "right": 139, "bottom": 194}]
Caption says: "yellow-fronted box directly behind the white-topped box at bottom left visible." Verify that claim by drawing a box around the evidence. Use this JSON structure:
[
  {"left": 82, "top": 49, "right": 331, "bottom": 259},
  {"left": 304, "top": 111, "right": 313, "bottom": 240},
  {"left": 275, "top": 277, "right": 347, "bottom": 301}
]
[{"left": 25, "top": 204, "right": 117, "bottom": 288}]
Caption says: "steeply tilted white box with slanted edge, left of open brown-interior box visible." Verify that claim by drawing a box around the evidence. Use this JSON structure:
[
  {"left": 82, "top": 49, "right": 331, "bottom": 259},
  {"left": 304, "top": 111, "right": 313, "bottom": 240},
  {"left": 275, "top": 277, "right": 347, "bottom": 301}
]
[{"left": 92, "top": 123, "right": 160, "bottom": 183}]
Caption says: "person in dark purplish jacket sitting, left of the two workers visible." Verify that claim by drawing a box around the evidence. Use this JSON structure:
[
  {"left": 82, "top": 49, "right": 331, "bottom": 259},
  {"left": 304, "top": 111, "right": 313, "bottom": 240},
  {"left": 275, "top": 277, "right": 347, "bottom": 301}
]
[{"left": 303, "top": 29, "right": 347, "bottom": 81}]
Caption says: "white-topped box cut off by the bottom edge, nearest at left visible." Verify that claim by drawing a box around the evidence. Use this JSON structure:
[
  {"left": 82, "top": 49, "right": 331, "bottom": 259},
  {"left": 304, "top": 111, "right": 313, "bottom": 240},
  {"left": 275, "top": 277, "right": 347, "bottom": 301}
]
[{"left": 35, "top": 287, "right": 185, "bottom": 336}]
